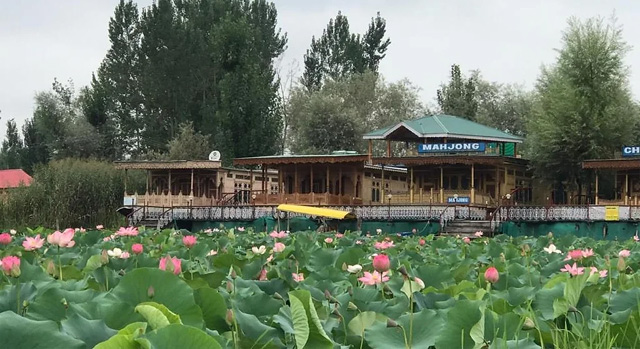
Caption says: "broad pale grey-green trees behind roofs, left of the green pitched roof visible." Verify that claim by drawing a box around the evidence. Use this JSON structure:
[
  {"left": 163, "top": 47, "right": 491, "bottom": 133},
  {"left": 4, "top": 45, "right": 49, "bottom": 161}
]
[{"left": 288, "top": 72, "right": 423, "bottom": 154}]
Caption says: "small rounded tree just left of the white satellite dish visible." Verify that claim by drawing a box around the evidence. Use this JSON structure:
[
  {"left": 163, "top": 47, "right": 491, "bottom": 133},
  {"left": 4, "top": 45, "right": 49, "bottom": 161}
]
[{"left": 167, "top": 122, "right": 211, "bottom": 160}]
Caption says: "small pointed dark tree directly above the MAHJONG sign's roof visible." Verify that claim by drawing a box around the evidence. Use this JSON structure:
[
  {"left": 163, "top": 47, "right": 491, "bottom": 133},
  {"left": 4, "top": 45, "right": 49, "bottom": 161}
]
[{"left": 436, "top": 64, "right": 478, "bottom": 120}]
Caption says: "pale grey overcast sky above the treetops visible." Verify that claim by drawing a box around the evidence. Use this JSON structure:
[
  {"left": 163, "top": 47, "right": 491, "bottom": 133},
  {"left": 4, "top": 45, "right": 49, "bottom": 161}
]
[{"left": 0, "top": 0, "right": 640, "bottom": 138}]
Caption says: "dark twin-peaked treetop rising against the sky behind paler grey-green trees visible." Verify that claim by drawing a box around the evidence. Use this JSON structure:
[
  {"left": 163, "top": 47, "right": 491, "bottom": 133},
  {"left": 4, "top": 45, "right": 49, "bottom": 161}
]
[{"left": 300, "top": 12, "right": 391, "bottom": 91}]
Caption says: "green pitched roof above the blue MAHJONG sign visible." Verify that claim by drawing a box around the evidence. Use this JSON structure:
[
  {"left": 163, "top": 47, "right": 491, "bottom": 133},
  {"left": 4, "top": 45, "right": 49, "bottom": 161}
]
[{"left": 363, "top": 115, "right": 523, "bottom": 143}]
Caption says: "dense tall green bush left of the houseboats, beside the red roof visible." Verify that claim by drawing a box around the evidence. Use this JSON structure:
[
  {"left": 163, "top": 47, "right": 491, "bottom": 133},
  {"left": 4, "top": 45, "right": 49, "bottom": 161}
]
[{"left": 0, "top": 159, "right": 124, "bottom": 228}]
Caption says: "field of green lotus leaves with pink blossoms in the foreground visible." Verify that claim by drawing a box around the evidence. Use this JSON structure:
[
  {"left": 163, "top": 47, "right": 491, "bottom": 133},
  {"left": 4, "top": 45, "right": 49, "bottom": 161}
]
[{"left": 0, "top": 227, "right": 640, "bottom": 349}]
